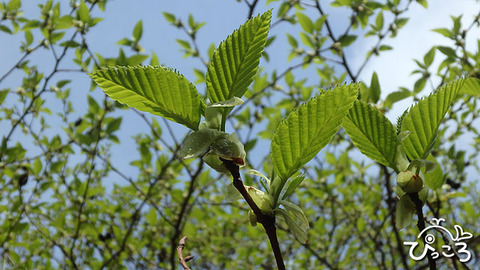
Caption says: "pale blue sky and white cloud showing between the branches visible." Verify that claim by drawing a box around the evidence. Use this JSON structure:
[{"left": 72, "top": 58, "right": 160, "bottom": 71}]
[{"left": 0, "top": 0, "right": 480, "bottom": 179}]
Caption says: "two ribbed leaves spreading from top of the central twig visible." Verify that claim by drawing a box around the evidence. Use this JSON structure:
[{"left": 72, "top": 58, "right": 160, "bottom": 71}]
[{"left": 89, "top": 11, "right": 271, "bottom": 130}]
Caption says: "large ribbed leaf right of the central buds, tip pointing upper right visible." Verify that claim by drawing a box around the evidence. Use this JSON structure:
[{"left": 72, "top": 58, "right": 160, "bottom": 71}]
[{"left": 270, "top": 84, "right": 358, "bottom": 181}]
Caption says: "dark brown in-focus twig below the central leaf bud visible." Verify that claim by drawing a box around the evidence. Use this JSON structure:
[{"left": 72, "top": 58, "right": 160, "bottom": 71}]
[{"left": 221, "top": 159, "right": 285, "bottom": 270}]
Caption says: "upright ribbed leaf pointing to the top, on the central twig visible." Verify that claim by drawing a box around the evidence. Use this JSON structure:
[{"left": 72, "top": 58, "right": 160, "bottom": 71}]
[{"left": 206, "top": 11, "right": 272, "bottom": 103}]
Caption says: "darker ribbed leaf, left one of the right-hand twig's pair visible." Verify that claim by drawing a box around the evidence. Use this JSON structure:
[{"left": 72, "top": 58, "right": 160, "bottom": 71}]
[{"left": 342, "top": 100, "right": 397, "bottom": 170}]
